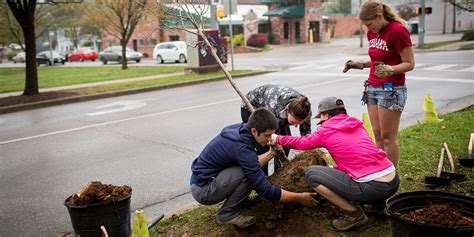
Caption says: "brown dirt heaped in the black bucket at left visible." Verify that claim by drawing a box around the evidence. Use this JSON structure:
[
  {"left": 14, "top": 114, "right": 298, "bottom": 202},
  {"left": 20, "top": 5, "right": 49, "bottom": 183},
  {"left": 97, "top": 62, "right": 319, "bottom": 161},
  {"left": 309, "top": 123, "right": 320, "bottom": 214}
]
[{"left": 68, "top": 181, "right": 132, "bottom": 205}]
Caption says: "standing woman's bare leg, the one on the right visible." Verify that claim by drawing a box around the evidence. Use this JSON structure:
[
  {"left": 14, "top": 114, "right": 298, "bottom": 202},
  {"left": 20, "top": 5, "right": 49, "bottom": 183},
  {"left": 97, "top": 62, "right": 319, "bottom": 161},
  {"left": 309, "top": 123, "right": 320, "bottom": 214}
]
[{"left": 378, "top": 107, "right": 402, "bottom": 166}]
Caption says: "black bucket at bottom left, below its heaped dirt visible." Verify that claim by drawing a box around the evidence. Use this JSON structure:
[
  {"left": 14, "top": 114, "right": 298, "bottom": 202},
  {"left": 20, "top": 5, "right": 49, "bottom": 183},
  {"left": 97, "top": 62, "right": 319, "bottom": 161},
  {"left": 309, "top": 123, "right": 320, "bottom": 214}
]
[{"left": 64, "top": 193, "right": 132, "bottom": 237}]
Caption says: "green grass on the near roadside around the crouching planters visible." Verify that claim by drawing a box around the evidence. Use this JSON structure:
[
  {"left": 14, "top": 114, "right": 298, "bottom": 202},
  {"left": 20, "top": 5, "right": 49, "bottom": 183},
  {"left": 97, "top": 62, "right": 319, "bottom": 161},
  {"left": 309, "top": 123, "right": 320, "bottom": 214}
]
[{"left": 151, "top": 107, "right": 474, "bottom": 236}]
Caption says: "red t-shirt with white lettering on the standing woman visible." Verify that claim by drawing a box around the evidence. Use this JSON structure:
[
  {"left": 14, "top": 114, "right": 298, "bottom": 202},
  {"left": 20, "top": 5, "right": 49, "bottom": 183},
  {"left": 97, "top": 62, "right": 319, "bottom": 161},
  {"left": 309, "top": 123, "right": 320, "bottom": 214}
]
[{"left": 367, "top": 21, "right": 412, "bottom": 86}]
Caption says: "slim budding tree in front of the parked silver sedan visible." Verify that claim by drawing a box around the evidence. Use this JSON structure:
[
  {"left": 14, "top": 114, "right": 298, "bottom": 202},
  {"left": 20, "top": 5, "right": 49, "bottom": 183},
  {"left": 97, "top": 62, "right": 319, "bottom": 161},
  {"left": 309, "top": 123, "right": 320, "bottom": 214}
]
[{"left": 91, "top": 0, "right": 158, "bottom": 69}]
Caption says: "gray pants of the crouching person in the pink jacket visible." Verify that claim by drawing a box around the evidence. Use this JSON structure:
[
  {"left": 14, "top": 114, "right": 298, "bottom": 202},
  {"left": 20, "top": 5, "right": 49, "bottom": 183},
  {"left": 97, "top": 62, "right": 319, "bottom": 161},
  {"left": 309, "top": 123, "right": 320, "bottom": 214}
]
[{"left": 306, "top": 166, "right": 400, "bottom": 204}]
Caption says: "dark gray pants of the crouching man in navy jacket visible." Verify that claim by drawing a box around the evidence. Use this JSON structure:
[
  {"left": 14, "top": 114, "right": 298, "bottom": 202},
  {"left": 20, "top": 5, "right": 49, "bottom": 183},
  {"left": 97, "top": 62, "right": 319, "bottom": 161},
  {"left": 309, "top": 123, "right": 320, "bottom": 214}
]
[{"left": 191, "top": 166, "right": 252, "bottom": 221}]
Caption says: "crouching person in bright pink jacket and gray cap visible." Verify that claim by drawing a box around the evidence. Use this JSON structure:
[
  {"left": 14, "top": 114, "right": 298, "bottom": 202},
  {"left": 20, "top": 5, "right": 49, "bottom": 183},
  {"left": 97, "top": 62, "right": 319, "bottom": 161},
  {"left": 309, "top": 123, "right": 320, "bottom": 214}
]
[{"left": 272, "top": 97, "right": 400, "bottom": 230}]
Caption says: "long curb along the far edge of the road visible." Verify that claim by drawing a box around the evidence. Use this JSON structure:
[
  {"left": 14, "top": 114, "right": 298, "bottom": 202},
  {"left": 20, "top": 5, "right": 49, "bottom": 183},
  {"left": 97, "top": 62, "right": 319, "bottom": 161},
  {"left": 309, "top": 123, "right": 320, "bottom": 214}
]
[{"left": 0, "top": 71, "right": 273, "bottom": 114}]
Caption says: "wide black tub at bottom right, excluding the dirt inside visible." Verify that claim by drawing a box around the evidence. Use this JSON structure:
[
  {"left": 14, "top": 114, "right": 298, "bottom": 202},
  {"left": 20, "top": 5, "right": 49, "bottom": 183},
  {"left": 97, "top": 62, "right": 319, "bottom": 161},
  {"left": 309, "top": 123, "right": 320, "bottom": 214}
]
[{"left": 385, "top": 191, "right": 474, "bottom": 237}]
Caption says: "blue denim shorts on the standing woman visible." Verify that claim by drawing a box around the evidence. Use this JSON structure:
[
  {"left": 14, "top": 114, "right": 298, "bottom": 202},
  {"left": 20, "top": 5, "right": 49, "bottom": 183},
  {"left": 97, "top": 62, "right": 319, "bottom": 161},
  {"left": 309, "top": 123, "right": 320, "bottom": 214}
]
[{"left": 367, "top": 85, "right": 407, "bottom": 112}]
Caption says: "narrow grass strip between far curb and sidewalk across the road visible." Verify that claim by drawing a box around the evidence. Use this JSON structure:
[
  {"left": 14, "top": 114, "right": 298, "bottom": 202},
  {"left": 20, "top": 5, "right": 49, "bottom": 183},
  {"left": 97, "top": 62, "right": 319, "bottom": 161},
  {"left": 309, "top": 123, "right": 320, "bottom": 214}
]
[{"left": 78, "top": 70, "right": 251, "bottom": 95}]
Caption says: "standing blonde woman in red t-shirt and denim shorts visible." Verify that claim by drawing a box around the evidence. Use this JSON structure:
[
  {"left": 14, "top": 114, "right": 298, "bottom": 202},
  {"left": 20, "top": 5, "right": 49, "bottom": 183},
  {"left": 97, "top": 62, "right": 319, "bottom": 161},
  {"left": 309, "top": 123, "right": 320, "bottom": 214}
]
[{"left": 343, "top": 1, "right": 415, "bottom": 165}]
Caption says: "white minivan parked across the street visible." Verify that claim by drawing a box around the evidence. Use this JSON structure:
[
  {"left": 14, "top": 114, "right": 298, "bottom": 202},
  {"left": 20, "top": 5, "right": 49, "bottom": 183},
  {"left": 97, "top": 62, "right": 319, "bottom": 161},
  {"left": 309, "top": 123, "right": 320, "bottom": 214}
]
[{"left": 153, "top": 41, "right": 188, "bottom": 63}]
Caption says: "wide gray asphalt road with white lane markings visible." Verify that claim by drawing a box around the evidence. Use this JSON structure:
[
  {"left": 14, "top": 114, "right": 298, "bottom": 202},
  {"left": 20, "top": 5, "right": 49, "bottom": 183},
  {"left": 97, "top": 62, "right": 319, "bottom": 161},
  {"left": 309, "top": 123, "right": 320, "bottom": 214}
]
[{"left": 0, "top": 39, "right": 474, "bottom": 236}]
